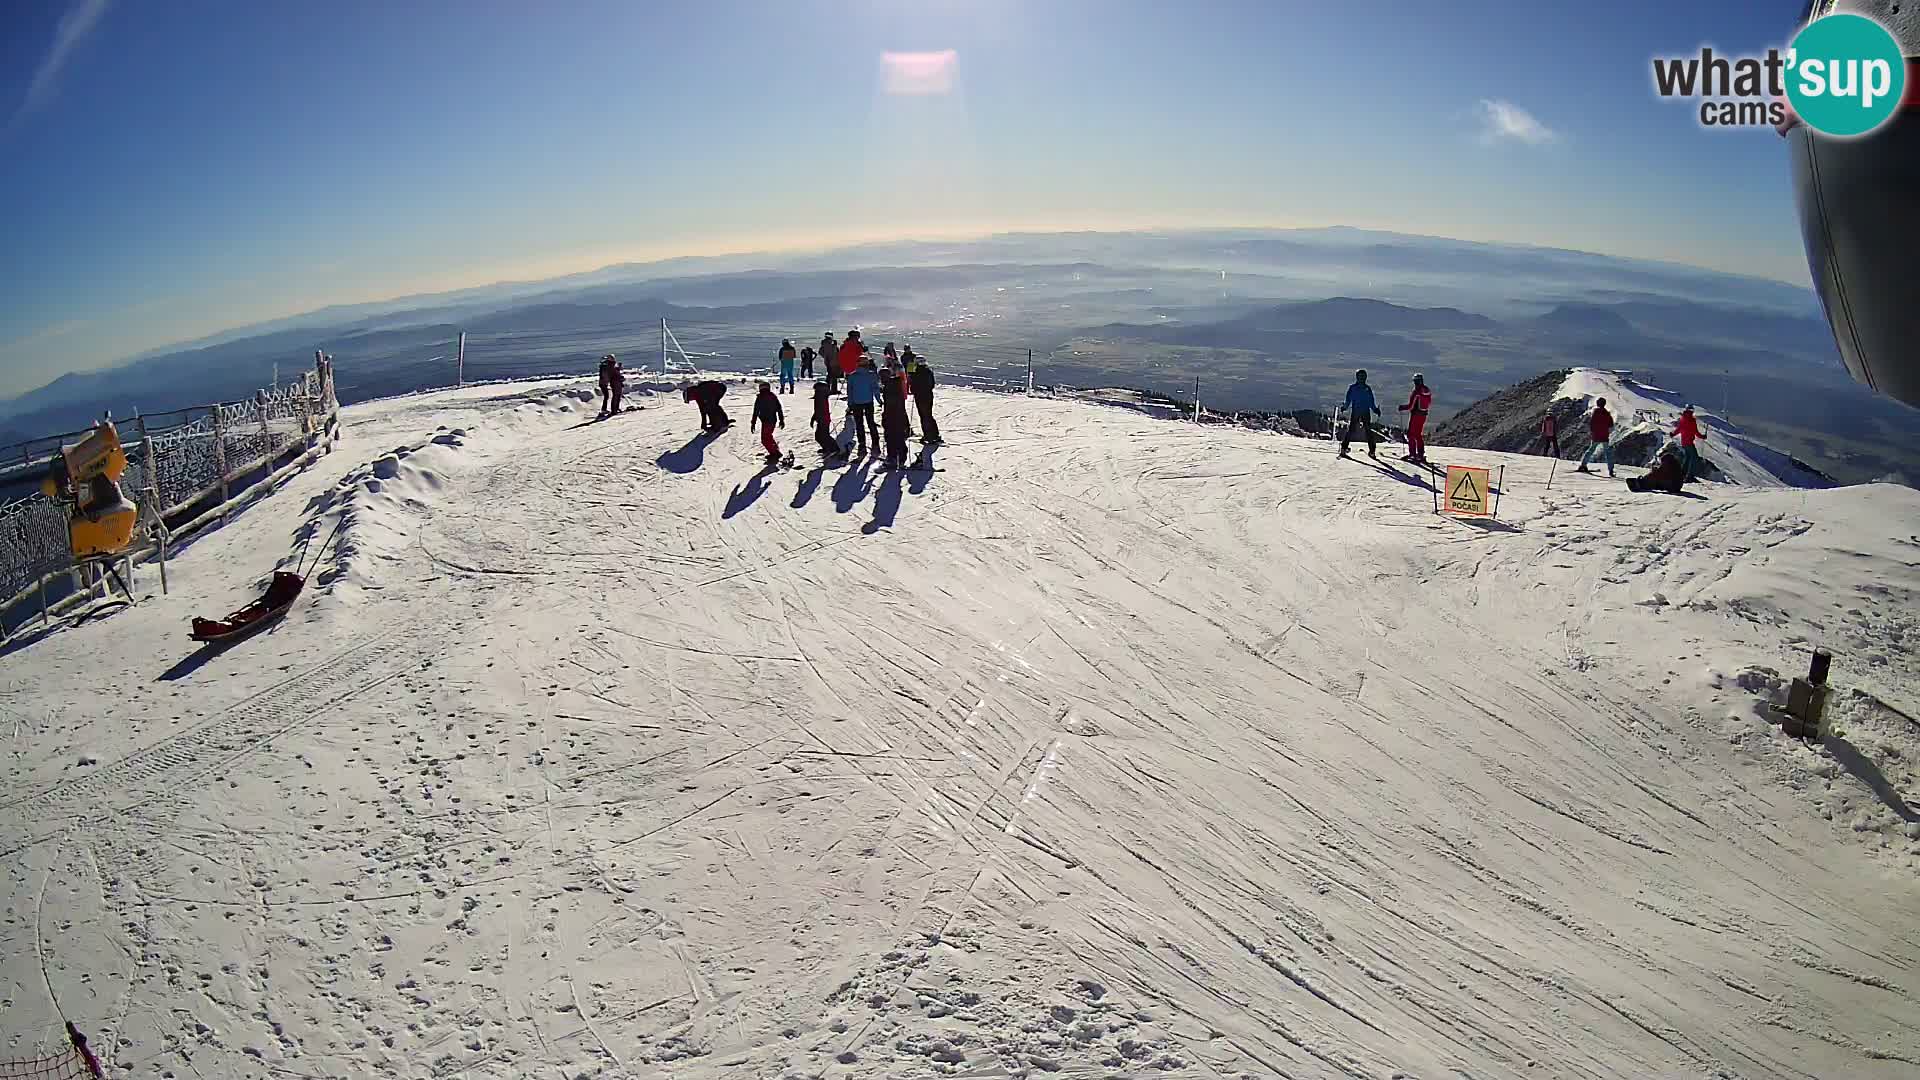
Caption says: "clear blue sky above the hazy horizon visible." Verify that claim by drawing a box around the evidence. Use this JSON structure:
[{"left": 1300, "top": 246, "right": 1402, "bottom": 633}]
[{"left": 0, "top": 0, "right": 1807, "bottom": 396}]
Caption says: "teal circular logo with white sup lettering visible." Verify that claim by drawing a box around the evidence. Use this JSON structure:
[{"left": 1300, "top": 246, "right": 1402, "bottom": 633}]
[{"left": 1788, "top": 13, "right": 1907, "bottom": 136}]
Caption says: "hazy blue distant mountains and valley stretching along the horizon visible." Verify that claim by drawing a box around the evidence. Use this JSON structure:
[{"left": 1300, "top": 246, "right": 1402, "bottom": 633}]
[{"left": 0, "top": 229, "right": 1920, "bottom": 479}]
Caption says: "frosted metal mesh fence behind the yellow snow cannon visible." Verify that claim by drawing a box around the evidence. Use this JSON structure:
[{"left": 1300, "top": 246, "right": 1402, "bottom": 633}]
[{"left": 0, "top": 357, "right": 340, "bottom": 630}]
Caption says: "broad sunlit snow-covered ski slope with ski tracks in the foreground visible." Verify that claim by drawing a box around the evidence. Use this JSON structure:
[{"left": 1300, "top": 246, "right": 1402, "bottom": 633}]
[{"left": 0, "top": 374, "right": 1920, "bottom": 1080}]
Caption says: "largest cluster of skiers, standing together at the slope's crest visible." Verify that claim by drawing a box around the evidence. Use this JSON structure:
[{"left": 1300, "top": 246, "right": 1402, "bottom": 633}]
[{"left": 675, "top": 331, "right": 941, "bottom": 471}]
